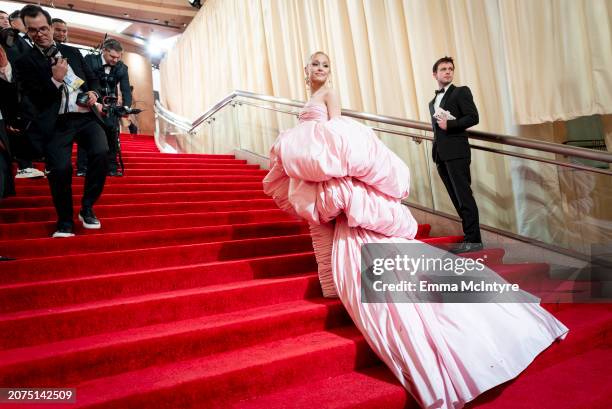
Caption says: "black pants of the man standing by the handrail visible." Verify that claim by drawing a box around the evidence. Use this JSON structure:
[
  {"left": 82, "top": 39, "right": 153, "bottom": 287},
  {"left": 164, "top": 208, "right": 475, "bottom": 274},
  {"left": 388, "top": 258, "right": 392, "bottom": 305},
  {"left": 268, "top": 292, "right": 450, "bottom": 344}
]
[{"left": 436, "top": 158, "right": 482, "bottom": 243}]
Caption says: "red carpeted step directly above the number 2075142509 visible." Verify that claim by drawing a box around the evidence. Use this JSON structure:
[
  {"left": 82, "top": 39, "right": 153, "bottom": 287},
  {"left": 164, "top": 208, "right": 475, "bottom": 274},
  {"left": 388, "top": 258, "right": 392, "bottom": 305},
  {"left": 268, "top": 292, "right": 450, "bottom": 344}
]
[{"left": 0, "top": 298, "right": 351, "bottom": 387}]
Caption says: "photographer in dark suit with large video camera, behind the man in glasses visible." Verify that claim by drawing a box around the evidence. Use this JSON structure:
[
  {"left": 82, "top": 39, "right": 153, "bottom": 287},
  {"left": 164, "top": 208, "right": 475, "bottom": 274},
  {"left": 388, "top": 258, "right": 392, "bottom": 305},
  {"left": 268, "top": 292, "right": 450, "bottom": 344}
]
[{"left": 77, "top": 39, "right": 132, "bottom": 176}]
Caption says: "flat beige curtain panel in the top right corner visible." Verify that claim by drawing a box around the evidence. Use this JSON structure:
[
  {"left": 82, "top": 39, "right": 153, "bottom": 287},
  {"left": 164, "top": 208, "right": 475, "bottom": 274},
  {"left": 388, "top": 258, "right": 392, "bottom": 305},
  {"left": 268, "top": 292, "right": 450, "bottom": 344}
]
[{"left": 499, "top": 0, "right": 612, "bottom": 124}]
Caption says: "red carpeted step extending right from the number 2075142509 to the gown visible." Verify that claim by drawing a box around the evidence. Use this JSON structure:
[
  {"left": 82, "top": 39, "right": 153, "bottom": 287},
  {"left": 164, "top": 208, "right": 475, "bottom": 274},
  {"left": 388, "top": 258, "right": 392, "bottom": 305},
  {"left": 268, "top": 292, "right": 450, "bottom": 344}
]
[{"left": 16, "top": 327, "right": 377, "bottom": 409}]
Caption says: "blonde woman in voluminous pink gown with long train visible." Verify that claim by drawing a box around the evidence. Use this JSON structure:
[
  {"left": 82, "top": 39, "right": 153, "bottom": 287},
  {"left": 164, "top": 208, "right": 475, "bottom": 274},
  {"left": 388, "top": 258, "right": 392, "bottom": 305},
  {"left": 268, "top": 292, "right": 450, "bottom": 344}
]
[{"left": 264, "top": 52, "right": 568, "bottom": 409}]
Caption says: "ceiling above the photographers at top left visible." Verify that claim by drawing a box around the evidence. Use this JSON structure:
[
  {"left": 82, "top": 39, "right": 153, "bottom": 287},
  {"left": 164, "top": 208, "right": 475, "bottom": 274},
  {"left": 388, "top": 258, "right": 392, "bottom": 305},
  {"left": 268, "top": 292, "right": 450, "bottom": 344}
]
[{"left": 6, "top": 0, "right": 203, "bottom": 52}]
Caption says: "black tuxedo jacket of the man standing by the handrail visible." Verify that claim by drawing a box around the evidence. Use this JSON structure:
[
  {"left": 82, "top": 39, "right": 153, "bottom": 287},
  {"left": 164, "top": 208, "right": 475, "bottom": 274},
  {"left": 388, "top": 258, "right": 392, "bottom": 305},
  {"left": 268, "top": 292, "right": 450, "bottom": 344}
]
[{"left": 429, "top": 84, "right": 478, "bottom": 162}]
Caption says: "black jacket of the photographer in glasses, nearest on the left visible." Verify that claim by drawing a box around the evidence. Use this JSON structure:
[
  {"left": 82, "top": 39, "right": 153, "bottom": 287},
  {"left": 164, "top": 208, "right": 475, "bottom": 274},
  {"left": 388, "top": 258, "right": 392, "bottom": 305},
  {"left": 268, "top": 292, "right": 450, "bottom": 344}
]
[{"left": 15, "top": 44, "right": 100, "bottom": 148}]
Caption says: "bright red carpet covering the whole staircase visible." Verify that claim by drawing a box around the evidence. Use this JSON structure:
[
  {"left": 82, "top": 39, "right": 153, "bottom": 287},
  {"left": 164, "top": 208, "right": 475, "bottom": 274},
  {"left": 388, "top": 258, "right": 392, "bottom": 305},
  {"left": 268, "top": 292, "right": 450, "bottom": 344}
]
[{"left": 0, "top": 136, "right": 612, "bottom": 409}]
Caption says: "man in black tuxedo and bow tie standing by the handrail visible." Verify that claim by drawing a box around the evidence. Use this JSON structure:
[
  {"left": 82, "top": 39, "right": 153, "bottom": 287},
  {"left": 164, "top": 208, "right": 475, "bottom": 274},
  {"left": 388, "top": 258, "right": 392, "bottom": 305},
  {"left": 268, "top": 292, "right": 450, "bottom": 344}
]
[{"left": 429, "top": 57, "right": 483, "bottom": 253}]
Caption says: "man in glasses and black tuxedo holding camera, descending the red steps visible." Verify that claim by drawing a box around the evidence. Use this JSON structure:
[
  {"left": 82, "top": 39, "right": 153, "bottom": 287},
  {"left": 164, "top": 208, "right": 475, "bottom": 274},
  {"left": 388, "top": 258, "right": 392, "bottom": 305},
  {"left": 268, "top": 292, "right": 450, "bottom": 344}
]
[{"left": 15, "top": 5, "right": 108, "bottom": 237}]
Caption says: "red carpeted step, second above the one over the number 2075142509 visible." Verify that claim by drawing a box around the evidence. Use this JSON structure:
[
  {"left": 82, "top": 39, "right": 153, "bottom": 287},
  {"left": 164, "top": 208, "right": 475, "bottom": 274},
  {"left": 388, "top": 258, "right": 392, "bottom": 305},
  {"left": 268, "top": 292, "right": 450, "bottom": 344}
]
[{"left": 0, "top": 251, "right": 317, "bottom": 313}]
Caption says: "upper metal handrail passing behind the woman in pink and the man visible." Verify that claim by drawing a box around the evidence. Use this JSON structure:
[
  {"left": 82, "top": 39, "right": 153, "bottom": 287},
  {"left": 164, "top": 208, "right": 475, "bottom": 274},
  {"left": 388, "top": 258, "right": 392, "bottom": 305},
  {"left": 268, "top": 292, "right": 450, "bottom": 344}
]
[{"left": 156, "top": 90, "right": 612, "bottom": 165}]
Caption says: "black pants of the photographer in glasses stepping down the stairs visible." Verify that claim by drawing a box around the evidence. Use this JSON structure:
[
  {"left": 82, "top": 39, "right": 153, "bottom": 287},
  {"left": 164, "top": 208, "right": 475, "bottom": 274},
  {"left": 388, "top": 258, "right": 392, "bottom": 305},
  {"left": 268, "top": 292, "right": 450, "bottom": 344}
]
[{"left": 45, "top": 113, "right": 108, "bottom": 228}]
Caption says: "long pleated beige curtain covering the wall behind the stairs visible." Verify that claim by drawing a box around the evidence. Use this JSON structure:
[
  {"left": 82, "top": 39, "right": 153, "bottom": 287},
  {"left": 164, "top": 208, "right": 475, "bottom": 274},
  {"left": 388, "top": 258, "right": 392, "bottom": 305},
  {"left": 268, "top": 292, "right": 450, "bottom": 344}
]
[{"left": 161, "top": 0, "right": 612, "bottom": 252}]
